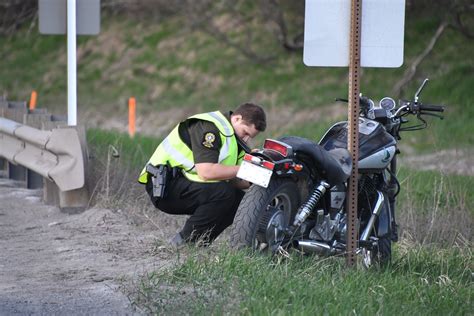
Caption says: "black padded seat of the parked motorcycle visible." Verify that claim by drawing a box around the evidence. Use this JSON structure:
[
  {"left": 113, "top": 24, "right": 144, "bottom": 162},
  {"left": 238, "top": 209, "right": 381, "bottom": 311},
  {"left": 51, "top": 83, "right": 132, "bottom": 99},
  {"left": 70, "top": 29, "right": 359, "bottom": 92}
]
[{"left": 279, "top": 136, "right": 352, "bottom": 185}]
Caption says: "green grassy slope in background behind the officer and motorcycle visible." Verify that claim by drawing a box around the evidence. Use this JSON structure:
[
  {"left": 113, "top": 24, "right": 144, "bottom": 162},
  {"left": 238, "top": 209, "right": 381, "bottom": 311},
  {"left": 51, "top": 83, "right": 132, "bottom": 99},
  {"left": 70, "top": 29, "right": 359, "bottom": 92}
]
[{"left": 0, "top": 15, "right": 474, "bottom": 151}]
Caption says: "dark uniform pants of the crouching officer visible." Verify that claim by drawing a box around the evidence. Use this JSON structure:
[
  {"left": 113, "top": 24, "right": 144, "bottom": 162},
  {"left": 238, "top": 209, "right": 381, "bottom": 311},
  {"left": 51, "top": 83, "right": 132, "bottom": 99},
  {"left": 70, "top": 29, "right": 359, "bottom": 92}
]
[{"left": 146, "top": 176, "right": 245, "bottom": 241}]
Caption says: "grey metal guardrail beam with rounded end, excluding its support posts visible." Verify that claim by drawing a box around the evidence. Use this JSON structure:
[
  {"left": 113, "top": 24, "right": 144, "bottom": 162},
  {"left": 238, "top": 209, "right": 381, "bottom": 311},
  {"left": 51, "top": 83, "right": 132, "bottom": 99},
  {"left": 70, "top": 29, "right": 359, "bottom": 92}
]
[{"left": 0, "top": 117, "right": 85, "bottom": 191}]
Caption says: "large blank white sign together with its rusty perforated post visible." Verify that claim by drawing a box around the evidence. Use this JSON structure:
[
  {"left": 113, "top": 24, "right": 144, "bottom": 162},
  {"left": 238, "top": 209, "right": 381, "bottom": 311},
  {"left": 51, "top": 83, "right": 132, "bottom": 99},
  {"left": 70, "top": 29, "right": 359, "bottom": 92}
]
[{"left": 303, "top": 0, "right": 405, "bottom": 266}]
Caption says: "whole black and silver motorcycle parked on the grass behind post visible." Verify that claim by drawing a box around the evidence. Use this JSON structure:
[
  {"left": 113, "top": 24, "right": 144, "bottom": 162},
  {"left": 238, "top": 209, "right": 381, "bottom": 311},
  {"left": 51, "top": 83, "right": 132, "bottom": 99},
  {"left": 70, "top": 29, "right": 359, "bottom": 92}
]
[{"left": 230, "top": 79, "right": 444, "bottom": 267}]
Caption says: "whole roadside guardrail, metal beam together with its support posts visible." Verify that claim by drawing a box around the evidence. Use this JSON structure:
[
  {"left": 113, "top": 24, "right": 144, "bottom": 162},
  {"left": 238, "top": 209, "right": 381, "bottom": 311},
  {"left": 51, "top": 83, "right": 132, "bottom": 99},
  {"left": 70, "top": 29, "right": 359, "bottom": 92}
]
[{"left": 0, "top": 96, "right": 90, "bottom": 213}]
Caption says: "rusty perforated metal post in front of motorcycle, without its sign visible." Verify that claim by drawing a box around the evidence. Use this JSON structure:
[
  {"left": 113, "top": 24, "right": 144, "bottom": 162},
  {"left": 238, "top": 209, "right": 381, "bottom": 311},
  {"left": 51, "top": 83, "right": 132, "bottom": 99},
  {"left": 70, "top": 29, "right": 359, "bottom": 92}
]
[{"left": 346, "top": 0, "right": 362, "bottom": 266}]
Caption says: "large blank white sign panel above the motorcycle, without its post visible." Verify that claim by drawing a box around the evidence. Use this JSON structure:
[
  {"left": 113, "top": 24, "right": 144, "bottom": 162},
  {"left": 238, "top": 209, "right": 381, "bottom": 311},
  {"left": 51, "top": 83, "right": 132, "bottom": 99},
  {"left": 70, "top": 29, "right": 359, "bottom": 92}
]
[{"left": 303, "top": 0, "right": 405, "bottom": 68}]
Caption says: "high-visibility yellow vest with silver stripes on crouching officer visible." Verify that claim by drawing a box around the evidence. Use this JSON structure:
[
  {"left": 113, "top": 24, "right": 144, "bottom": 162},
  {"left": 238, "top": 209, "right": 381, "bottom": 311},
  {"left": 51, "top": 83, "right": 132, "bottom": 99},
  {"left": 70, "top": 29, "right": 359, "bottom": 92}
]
[{"left": 138, "top": 111, "right": 245, "bottom": 184}]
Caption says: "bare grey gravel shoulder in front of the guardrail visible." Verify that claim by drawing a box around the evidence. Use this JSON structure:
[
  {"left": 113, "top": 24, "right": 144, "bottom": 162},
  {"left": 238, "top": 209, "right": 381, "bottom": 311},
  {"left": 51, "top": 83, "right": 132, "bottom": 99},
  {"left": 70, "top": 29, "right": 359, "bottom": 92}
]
[{"left": 0, "top": 178, "right": 180, "bottom": 315}]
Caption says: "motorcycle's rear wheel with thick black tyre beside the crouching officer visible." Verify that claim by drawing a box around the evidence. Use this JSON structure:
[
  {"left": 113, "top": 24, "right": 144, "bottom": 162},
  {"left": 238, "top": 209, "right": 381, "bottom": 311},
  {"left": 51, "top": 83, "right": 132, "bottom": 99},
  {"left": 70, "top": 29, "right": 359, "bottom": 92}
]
[{"left": 230, "top": 178, "right": 300, "bottom": 250}]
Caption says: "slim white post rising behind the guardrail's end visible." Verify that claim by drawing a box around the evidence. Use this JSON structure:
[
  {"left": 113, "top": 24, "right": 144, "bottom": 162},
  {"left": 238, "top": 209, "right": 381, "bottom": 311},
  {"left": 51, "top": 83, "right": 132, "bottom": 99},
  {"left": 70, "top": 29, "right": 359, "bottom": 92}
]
[{"left": 67, "top": 0, "right": 77, "bottom": 126}]
